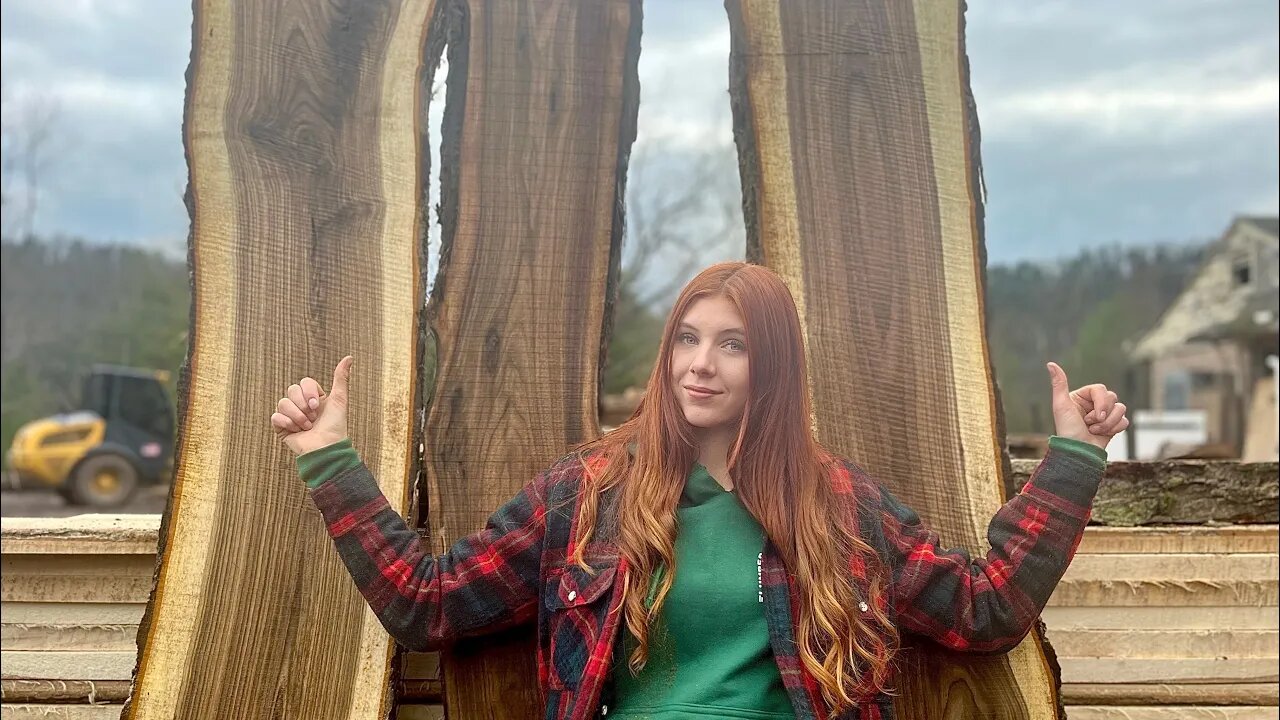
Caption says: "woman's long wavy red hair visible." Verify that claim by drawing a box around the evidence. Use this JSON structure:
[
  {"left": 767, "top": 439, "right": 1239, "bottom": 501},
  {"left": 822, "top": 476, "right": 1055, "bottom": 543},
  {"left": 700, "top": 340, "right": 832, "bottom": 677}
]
[{"left": 573, "top": 263, "right": 899, "bottom": 710}]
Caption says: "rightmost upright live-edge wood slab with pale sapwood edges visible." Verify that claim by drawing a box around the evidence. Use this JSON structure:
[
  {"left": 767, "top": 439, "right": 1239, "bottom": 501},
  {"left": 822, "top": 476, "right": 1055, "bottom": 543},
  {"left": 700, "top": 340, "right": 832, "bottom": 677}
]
[{"left": 726, "top": 0, "right": 1061, "bottom": 719}]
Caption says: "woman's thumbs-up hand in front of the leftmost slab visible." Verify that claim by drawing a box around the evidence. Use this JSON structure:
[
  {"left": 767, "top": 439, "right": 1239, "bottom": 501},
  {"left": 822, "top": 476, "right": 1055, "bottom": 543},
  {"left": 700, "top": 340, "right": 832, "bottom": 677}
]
[{"left": 271, "top": 355, "right": 355, "bottom": 455}]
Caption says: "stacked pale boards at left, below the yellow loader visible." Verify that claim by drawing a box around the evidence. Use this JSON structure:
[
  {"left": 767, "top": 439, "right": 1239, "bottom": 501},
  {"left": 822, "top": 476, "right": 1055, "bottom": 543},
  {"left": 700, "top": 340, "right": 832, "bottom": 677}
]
[{"left": 0, "top": 515, "right": 160, "bottom": 720}]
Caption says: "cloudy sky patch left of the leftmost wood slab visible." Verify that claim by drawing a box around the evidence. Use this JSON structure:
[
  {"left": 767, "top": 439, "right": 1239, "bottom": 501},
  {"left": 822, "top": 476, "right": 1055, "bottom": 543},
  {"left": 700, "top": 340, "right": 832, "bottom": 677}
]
[{"left": 0, "top": 0, "right": 191, "bottom": 254}]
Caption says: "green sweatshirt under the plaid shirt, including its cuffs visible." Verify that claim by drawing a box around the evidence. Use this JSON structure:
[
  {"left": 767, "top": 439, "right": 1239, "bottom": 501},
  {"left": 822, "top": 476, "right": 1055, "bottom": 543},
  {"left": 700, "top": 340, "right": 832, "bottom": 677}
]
[{"left": 297, "top": 436, "right": 1106, "bottom": 720}]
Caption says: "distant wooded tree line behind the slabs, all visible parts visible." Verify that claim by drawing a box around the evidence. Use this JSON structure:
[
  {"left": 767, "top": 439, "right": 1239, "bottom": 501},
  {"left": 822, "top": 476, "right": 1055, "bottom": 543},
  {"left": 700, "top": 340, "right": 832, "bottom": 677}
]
[{"left": 0, "top": 233, "right": 1204, "bottom": 448}]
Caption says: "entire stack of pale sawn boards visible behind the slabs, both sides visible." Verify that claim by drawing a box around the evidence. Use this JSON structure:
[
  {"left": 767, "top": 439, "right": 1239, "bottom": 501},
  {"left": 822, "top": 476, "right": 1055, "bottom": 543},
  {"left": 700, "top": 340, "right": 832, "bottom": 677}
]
[{"left": 0, "top": 515, "right": 1280, "bottom": 720}]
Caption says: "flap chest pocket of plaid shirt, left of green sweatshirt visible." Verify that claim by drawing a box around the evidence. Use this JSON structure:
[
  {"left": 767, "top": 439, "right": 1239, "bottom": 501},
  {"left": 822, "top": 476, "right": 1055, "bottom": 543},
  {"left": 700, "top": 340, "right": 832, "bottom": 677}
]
[{"left": 543, "top": 565, "right": 617, "bottom": 689}]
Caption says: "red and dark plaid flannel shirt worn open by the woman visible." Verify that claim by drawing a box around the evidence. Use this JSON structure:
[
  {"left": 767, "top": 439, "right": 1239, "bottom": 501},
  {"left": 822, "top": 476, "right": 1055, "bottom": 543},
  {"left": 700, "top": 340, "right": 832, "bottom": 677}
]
[{"left": 311, "top": 438, "right": 1106, "bottom": 720}]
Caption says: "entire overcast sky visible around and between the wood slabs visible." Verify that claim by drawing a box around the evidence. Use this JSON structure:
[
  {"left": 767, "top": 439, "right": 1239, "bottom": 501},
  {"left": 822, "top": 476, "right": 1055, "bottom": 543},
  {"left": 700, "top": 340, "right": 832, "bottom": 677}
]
[{"left": 0, "top": 0, "right": 1280, "bottom": 263}]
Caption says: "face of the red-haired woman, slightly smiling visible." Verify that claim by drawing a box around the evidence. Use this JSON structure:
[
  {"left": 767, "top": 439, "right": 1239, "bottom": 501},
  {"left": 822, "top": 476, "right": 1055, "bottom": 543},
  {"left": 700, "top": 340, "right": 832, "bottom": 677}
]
[{"left": 671, "top": 297, "right": 750, "bottom": 430}]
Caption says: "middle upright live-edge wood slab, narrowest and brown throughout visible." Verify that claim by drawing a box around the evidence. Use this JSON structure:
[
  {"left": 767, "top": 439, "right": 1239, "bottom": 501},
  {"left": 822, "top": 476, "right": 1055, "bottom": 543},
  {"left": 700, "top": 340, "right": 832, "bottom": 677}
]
[{"left": 424, "top": 0, "right": 640, "bottom": 720}]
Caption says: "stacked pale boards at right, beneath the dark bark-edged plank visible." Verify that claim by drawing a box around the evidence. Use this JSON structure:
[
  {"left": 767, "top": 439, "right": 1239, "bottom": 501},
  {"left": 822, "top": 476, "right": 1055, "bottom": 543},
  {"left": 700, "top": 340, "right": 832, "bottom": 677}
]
[{"left": 1043, "top": 525, "right": 1280, "bottom": 720}]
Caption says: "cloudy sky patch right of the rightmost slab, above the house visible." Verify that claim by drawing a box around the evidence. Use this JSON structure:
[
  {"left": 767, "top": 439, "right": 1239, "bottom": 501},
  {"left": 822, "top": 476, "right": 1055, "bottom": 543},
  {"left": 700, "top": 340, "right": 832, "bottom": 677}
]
[{"left": 968, "top": 0, "right": 1280, "bottom": 260}]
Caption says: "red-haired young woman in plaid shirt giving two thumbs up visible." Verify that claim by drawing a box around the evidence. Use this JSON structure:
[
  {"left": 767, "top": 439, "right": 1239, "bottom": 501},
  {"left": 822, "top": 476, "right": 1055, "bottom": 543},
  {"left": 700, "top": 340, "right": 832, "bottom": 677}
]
[{"left": 271, "top": 263, "right": 1129, "bottom": 720}]
